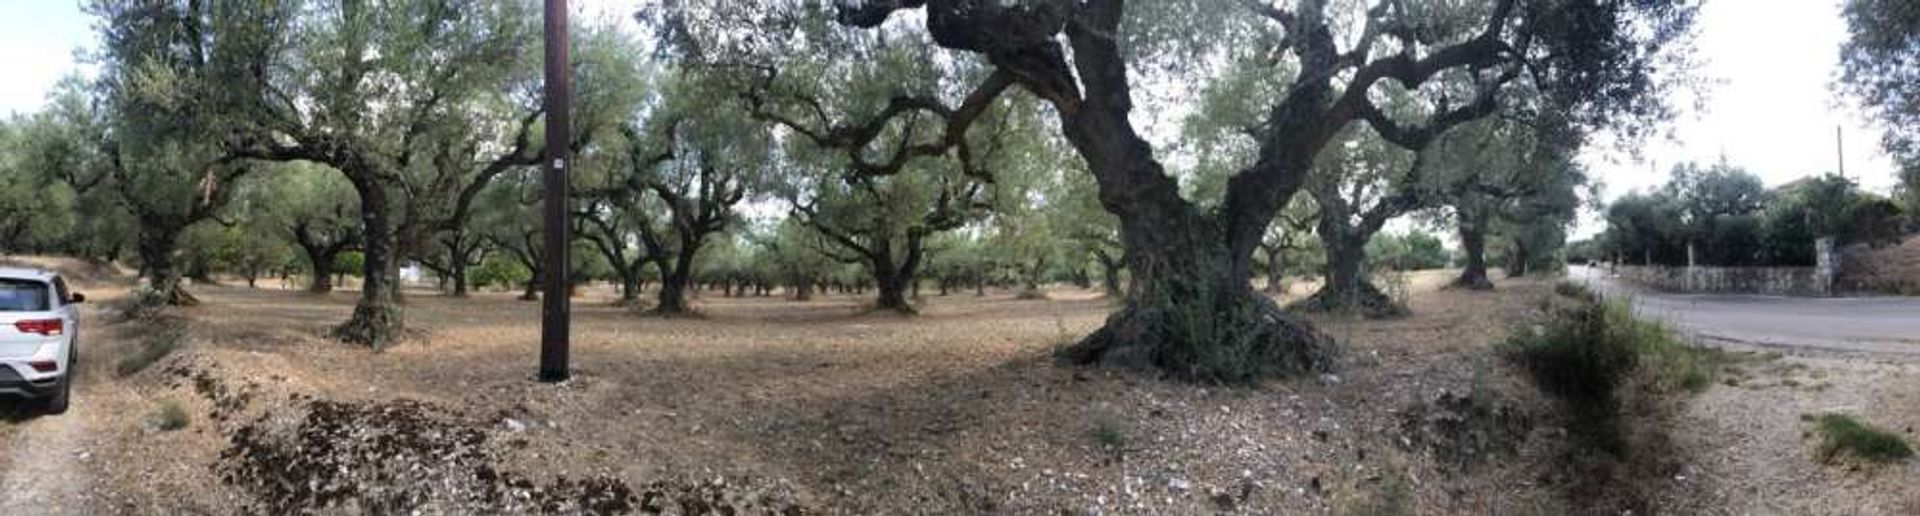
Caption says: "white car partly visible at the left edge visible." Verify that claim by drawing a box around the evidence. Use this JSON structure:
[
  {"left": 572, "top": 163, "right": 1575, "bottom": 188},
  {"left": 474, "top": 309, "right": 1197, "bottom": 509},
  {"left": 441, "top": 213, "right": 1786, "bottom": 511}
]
[{"left": 0, "top": 267, "right": 86, "bottom": 414}]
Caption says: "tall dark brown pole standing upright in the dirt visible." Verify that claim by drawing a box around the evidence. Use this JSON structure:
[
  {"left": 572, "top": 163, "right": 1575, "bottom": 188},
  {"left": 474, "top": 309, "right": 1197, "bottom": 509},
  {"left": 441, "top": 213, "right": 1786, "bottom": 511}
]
[{"left": 540, "top": 0, "right": 572, "bottom": 382}]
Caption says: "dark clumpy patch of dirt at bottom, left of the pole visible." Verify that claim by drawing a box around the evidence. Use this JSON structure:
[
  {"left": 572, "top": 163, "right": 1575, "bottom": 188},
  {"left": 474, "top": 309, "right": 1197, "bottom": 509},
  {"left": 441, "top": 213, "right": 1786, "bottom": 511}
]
[{"left": 215, "top": 395, "right": 808, "bottom": 514}]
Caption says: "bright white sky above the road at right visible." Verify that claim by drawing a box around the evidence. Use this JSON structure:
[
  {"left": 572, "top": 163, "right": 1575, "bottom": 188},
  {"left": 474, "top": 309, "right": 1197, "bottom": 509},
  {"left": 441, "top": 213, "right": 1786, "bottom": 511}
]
[{"left": 1576, "top": 0, "right": 1897, "bottom": 236}]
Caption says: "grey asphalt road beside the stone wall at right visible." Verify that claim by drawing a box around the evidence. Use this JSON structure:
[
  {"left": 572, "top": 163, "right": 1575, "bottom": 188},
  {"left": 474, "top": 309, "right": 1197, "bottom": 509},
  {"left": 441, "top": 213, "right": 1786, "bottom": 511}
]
[{"left": 1569, "top": 267, "right": 1920, "bottom": 352}]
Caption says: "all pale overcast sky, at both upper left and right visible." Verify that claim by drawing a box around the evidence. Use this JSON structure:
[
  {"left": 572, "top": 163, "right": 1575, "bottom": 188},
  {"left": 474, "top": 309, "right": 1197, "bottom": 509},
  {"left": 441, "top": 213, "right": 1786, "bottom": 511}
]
[{"left": 0, "top": 0, "right": 1895, "bottom": 236}]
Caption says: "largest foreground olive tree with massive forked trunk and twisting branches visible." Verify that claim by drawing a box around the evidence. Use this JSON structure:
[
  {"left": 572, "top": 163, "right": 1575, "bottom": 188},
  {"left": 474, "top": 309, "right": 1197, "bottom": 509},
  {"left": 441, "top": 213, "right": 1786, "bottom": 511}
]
[{"left": 670, "top": 0, "right": 1692, "bottom": 382}]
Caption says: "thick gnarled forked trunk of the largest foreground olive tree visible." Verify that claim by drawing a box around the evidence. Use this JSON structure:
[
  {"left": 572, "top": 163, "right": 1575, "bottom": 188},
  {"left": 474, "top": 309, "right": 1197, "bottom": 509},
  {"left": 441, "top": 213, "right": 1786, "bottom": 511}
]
[{"left": 1062, "top": 101, "right": 1338, "bottom": 384}]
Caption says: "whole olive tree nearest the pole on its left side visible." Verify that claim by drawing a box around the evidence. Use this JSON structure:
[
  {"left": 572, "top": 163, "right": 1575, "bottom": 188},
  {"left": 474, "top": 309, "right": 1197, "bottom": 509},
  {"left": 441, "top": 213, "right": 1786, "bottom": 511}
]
[{"left": 223, "top": 0, "right": 538, "bottom": 347}]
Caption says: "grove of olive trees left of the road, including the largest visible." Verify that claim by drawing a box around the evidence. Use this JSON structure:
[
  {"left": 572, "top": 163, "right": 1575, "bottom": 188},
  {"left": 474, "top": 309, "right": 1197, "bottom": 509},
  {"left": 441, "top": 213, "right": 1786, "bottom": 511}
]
[{"left": 0, "top": 0, "right": 1692, "bottom": 382}]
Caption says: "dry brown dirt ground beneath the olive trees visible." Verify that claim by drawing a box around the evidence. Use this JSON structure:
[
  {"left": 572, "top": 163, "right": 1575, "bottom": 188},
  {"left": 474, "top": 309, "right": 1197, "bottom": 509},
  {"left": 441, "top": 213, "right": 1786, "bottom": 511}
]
[{"left": 0, "top": 258, "right": 1920, "bottom": 514}]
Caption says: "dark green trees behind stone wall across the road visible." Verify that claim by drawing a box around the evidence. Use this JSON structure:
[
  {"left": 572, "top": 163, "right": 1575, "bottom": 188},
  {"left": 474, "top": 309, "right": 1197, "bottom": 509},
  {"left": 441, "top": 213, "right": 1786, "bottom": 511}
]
[{"left": 1584, "top": 163, "right": 1907, "bottom": 267}]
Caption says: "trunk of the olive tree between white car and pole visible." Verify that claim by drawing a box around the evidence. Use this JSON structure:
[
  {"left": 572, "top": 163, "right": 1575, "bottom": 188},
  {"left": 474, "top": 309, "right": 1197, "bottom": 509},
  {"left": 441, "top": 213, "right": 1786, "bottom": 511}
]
[{"left": 334, "top": 180, "right": 405, "bottom": 349}]
